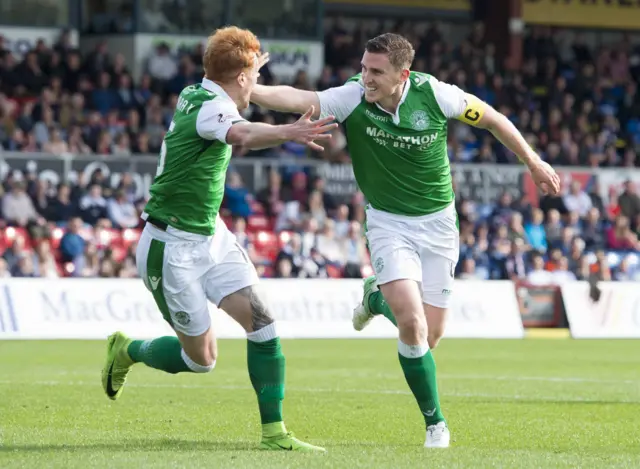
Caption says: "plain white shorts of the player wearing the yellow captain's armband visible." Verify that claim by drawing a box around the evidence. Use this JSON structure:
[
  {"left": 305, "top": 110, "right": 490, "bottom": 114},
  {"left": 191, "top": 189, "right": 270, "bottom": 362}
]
[{"left": 366, "top": 204, "right": 460, "bottom": 308}]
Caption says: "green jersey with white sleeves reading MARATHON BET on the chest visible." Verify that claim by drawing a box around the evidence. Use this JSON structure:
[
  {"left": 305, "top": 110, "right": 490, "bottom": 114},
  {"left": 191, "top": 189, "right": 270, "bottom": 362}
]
[{"left": 318, "top": 72, "right": 467, "bottom": 216}]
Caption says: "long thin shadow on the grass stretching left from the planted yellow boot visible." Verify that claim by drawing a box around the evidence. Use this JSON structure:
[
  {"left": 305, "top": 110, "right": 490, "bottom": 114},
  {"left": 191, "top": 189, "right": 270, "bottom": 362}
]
[{"left": 0, "top": 438, "right": 258, "bottom": 453}]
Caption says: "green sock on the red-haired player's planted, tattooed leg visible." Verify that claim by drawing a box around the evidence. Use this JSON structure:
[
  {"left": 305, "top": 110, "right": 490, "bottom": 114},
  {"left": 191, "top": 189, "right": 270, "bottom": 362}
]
[{"left": 247, "top": 334, "right": 285, "bottom": 426}]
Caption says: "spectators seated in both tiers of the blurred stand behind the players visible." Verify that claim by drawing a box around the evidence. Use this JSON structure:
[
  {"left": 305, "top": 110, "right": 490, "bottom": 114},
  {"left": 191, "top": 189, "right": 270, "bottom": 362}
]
[{"left": 0, "top": 19, "right": 640, "bottom": 283}]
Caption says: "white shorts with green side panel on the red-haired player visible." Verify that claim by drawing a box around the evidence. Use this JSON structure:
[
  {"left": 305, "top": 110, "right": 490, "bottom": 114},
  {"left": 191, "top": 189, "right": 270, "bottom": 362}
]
[{"left": 136, "top": 219, "right": 258, "bottom": 336}]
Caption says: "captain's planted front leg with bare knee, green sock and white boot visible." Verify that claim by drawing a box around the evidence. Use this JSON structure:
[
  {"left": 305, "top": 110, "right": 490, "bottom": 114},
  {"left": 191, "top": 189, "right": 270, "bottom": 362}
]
[{"left": 379, "top": 279, "right": 450, "bottom": 448}]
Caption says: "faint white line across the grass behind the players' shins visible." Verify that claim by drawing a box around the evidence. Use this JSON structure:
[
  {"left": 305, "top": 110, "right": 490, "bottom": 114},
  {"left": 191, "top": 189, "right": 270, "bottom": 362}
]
[{"left": 0, "top": 380, "right": 640, "bottom": 404}]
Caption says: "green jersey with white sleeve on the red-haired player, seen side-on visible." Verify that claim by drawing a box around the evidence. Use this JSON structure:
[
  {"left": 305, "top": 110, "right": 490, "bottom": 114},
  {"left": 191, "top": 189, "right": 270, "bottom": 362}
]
[{"left": 143, "top": 78, "right": 244, "bottom": 236}]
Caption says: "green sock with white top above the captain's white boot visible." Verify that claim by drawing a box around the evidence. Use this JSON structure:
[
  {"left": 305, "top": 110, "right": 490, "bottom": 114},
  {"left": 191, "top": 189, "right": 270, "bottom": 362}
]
[{"left": 398, "top": 342, "right": 445, "bottom": 426}]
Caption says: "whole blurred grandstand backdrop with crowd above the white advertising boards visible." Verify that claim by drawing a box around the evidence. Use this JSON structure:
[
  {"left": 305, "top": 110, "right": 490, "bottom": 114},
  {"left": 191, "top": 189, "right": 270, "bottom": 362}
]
[{"left": 0, "top": 0, "right": 640, "bottom": 324}]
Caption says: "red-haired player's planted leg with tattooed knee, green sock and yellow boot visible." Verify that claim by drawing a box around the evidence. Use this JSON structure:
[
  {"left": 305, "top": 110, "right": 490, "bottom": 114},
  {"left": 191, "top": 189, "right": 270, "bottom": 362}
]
[{"left": 220, "top": 287, "right": 324, "bottom": 451}]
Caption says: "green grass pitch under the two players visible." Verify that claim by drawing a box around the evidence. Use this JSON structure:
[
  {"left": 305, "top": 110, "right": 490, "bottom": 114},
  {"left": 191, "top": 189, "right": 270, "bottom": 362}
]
[{"left": 0, "top": 339, "right": 640, "bottom": 469}]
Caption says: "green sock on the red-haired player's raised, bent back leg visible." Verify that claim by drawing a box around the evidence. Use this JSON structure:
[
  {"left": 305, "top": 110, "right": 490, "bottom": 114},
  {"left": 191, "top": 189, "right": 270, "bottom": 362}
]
[{"left": 127, "top": 336, "right": 193, "bottom": 374}]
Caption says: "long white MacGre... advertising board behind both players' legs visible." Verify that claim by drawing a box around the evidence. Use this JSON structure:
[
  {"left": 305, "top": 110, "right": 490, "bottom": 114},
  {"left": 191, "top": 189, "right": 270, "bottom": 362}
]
[{"left": 0, "top": 279, "right": 524, "bottom": 339}]
